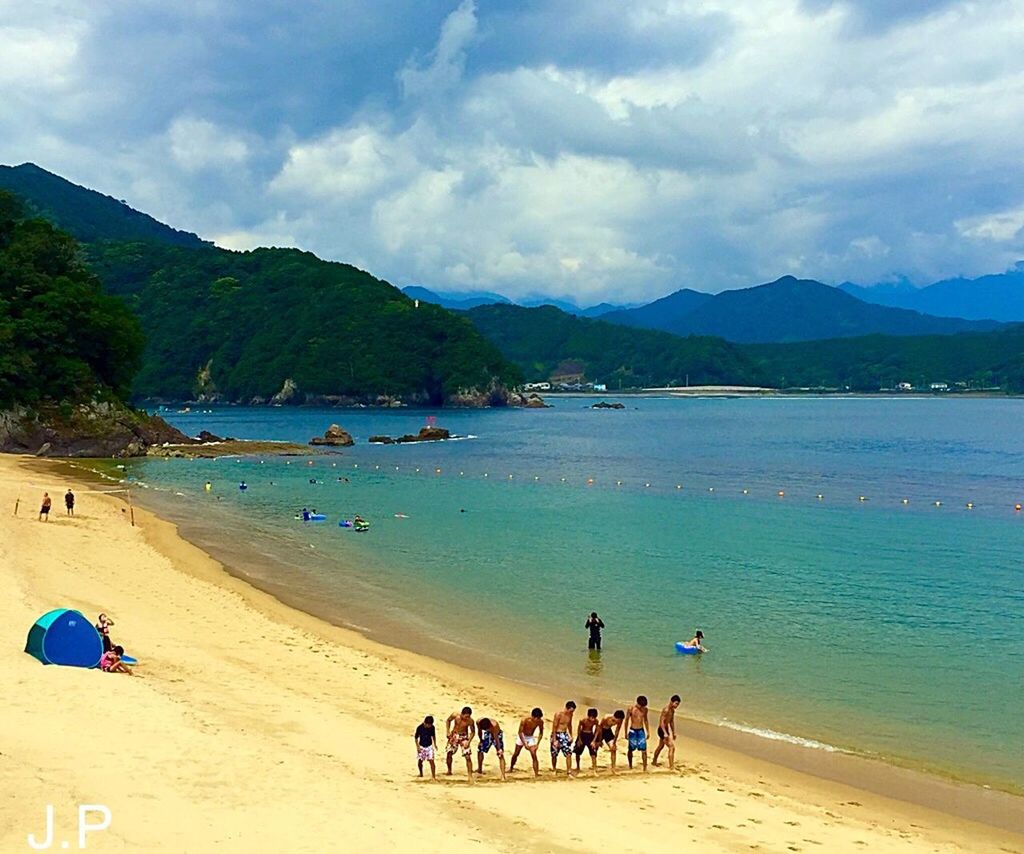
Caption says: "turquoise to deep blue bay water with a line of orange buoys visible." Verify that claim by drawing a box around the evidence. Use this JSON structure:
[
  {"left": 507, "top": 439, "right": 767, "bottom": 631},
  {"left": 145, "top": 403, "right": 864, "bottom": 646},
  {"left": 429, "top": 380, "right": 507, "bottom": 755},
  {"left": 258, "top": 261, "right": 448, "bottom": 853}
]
[{"left": 126, "top": 397, "right": 1024, "bottom": 792}]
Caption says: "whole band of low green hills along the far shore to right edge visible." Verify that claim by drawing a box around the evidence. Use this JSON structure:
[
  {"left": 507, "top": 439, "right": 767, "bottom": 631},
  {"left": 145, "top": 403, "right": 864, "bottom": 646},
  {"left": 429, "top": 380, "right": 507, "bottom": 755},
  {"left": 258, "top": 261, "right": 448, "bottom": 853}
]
[{"left": 468, "top": 305, "right": 1024, "bottom": 392}]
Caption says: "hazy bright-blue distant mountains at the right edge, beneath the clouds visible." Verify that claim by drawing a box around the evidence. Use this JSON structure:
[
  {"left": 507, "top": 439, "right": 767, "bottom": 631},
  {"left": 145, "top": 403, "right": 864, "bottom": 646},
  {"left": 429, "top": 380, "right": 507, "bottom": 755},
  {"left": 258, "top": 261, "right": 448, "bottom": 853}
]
[{"left": 840, "top": 261, "right": 1024, "bottom": 322}]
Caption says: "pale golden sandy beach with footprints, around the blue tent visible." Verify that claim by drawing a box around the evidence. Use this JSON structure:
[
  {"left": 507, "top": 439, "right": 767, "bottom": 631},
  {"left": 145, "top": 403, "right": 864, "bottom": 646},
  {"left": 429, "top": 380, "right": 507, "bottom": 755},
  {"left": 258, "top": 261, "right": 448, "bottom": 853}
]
[{"left": 0, "top": 448, "right": 1024, "bottom": 852}]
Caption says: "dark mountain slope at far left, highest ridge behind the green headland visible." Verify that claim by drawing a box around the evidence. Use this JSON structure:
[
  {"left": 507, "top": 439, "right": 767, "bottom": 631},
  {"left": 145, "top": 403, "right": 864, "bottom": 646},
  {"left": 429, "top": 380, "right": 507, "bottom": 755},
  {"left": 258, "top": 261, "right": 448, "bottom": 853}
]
[{"left": 0, "top": 163, "right": 207, "bottom": 246}]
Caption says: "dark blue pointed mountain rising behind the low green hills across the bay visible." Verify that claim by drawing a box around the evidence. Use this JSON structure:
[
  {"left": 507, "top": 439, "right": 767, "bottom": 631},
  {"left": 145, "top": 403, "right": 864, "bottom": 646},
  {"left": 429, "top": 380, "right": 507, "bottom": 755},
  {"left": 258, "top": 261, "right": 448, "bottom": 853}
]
[{"left": 601, "top": 275, "right": 998, "bottom": 344}]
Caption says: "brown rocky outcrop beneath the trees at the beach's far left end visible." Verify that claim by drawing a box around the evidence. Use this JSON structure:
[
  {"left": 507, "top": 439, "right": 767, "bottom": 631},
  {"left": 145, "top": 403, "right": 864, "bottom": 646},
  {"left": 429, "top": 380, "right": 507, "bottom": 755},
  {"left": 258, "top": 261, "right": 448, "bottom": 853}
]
[{"left": 0, "top": 401, "right": 195, "bottom": 457}]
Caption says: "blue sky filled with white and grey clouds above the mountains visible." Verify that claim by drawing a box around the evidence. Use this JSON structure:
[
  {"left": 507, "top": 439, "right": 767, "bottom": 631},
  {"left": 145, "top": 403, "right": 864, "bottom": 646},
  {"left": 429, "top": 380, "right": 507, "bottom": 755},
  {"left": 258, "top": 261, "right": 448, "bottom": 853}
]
[{"left": 0, "top": 0, "right": 1024, "bottom": 303}]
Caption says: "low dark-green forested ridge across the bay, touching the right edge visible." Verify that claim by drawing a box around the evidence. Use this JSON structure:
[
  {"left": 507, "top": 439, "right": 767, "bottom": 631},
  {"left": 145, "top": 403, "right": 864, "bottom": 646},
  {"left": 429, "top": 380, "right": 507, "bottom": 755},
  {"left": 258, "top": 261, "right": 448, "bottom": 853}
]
[{"left": 744, "top": 326, "right": 1024, "bottom": 392}]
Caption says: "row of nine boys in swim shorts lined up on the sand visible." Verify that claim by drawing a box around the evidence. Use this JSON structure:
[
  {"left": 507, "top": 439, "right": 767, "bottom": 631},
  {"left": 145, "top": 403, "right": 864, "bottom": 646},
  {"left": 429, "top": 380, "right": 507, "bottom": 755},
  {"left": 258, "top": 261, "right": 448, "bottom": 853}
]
[{"left": 413, "top": 694, "right": 680, "bottom": 784}]
